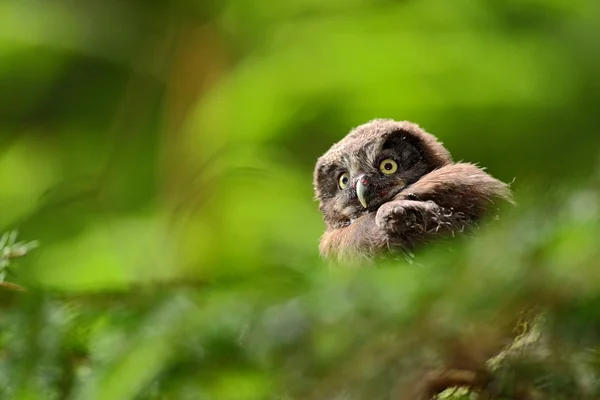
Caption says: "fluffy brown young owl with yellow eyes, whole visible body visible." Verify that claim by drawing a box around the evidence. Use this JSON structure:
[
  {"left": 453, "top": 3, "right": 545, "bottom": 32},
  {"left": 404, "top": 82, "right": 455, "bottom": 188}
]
[{"left": 313, "top": 119, "right": 512, "bottom": 261}]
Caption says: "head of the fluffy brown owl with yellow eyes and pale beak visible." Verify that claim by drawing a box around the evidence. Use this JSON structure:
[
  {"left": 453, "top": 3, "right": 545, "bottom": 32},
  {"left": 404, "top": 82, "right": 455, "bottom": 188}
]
[{"left": 314, "top": 119, "right": 452, "bottom": 228}]
